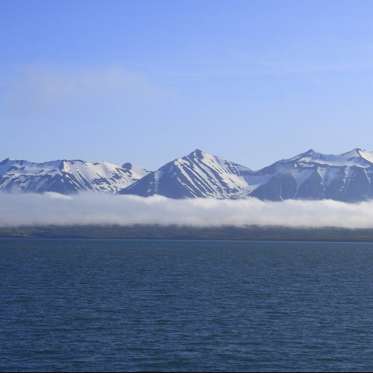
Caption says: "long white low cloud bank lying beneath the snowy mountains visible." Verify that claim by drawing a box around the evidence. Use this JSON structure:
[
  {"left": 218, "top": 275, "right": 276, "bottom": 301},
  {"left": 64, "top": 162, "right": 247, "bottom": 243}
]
[{"left": 0, "top": 193, "right": 373, "bottom": 228}]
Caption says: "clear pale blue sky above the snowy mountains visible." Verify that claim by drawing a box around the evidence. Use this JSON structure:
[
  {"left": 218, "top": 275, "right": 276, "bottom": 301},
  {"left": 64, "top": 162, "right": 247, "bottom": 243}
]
[{"left": 0, "top": 0, "right": 373, "bottom": 169}]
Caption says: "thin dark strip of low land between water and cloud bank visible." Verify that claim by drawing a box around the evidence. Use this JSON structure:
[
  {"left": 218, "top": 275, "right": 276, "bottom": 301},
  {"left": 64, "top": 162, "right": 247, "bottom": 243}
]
[{"left": 0, "top": 225, "right": 373, "bottom": 241}]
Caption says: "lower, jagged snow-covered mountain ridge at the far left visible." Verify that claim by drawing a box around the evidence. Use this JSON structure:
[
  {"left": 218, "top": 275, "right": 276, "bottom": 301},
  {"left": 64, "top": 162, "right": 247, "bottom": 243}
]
[{"left": 0, "top": 159, "right": 147, "bottom": 194}]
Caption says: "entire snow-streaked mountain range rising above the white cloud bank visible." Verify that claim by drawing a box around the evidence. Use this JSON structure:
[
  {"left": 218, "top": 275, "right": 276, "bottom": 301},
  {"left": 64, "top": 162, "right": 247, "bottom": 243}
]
[{"left": 0, "top": 148, "right": 373, "bottom": 202}]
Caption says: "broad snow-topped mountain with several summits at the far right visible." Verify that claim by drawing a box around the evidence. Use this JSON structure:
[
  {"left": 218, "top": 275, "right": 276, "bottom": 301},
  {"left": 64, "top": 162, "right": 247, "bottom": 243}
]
[{"left": 247, "top": 148, "right": 373, "bottom": 202}]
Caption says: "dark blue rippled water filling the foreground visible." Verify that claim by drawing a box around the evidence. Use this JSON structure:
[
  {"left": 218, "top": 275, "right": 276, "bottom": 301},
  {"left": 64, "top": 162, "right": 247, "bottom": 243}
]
[{"left": 0, "top": 239, "right": 373, "bottom": 371}]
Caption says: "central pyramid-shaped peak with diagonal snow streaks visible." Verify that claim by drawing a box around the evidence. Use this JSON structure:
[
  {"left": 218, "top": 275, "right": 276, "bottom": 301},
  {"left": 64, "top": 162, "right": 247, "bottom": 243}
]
[{"left": 120, "top": 149, "right": 251, "bottom": 199}]
